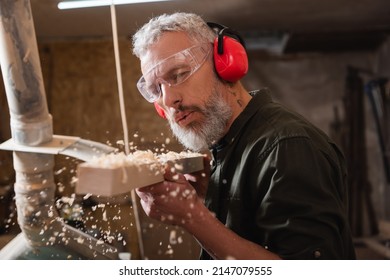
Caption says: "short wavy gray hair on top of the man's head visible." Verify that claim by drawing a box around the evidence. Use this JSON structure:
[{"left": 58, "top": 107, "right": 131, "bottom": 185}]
[{"left": 133, "top": 12, "right": 215, "bottom": 58}]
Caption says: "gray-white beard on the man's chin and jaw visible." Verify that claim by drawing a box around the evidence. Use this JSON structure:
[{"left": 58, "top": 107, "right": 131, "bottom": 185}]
[{"left": 169, "top": 90, "right": 233, "bottom": 152}]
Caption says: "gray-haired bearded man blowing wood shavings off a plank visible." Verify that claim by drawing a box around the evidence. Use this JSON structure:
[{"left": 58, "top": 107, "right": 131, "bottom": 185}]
[{"left": 133, "top": 13, "right": 355, "bottom": 259}]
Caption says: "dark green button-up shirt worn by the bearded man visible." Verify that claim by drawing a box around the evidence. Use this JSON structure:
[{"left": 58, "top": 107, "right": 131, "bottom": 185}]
[{"left": 202, "top": 90, "right": 355, "bottom": 259}]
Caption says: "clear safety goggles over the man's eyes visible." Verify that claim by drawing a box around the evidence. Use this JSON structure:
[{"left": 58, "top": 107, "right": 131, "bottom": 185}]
[{"left": 137, "top": 44, "right": 211, "bottom": 103}]
